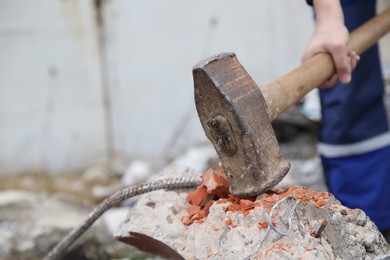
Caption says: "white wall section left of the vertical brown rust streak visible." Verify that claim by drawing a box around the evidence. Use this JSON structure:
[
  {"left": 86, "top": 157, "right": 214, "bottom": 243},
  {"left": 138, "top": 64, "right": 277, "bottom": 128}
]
[{"left": 0, "top": 0, "right": 107, "bottom": 173}]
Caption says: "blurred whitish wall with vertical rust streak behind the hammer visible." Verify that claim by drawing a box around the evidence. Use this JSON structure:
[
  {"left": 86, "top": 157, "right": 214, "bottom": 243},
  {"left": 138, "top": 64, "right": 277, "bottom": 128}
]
[{"left": 0, "top": 0, "right": 390, "bottom": 175}]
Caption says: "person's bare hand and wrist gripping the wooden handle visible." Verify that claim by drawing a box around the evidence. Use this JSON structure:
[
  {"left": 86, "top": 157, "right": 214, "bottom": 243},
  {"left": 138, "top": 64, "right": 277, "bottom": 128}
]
[{"left": 302, "top": 0, "right": 360, "bottom": 88}]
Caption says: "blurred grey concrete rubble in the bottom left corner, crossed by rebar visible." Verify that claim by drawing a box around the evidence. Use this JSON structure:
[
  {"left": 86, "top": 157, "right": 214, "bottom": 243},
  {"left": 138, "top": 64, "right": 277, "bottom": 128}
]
[{"left": 0, "top": 190, "right": 114, "bottom": 259}]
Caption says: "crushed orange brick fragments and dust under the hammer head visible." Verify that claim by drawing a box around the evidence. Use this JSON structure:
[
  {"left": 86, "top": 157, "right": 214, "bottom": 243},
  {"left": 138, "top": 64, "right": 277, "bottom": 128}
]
[{"left": 182, "top": 165, "right": 329, "bottom": 225}]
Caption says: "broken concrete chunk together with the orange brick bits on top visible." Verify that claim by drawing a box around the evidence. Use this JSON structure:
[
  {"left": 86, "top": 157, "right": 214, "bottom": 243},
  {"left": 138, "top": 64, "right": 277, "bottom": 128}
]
[{"left": 116, "top": 166, "right": 390, "bottom": 259}]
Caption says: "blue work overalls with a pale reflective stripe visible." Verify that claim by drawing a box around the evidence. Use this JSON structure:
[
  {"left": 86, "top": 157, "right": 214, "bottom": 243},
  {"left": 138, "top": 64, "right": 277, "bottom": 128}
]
[{"left": 318, "top": 0, "right": 390, "bottom": 230}]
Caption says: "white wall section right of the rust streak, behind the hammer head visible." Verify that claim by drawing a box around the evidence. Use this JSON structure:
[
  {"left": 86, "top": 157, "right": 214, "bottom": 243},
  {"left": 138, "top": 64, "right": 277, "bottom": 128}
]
[{"left": 104, "top": 0, "right": 311, "bottom": 164}]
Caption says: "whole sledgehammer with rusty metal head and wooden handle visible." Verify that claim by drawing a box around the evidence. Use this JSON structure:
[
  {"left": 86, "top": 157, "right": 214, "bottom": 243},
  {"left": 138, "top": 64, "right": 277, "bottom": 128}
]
[{"left": 193, "top": 9, "right": 390, "bottom": 197}]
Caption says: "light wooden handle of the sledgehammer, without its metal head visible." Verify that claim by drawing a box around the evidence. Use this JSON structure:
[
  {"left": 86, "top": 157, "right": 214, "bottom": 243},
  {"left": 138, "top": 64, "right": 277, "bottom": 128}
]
[{"left": 261, "top": 8, "right": 390, "bottom": 122}]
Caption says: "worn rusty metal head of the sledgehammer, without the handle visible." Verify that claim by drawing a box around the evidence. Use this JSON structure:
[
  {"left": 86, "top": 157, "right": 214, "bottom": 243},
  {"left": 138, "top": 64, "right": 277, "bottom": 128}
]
[{"left": 193, "top": 53, "right": 290, "bottom": 197}]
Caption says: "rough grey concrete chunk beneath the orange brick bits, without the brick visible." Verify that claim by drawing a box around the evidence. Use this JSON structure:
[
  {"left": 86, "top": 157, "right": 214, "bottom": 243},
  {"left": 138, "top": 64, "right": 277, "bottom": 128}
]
[{"left": 116, "top": 168, "right": 390, "bottom": 259}]
